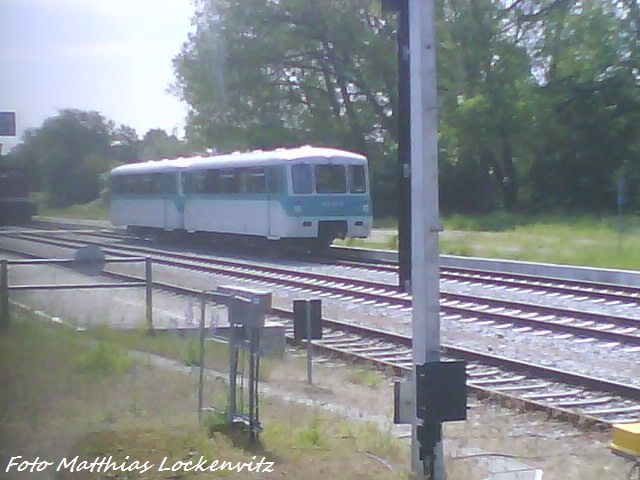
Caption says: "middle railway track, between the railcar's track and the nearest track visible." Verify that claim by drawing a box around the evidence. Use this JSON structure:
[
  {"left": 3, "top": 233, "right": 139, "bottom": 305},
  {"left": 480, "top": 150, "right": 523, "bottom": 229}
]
[{"left": 9, "top": 230, "right": 640, "bottom": 351}]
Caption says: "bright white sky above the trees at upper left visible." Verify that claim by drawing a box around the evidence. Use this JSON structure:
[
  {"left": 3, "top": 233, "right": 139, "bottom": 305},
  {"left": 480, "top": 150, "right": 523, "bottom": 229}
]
[{"left": 0, "top": 0, "right": 194, "bottom": 153}]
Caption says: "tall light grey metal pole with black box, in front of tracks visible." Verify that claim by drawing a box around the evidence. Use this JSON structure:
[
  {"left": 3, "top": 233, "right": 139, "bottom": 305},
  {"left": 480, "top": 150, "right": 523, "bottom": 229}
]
[{"left": 409, "top": 0, "right": 444, "bottom": 480}]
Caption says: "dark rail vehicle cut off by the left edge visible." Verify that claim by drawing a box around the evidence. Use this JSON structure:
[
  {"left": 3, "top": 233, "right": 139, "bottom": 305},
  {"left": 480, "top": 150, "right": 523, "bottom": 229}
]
[{"left": 0, "top": 166, "right": 37, "bottom": 224}]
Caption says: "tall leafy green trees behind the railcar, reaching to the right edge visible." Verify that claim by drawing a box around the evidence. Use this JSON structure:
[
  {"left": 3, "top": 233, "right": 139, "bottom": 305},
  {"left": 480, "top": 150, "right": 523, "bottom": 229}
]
[{"left": 174, "top": 0, "right": 640, "bottom": 215}]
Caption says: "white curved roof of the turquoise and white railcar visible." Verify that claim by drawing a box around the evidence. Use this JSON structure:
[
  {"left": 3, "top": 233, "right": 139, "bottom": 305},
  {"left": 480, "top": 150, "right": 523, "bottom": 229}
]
[{"left": 111, "top": 145, "right": 366, "bottom": 175}]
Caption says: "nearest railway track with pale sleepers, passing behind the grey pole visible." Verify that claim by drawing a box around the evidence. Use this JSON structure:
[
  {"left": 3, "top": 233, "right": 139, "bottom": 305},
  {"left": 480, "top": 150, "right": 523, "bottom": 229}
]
[{"left": 6, "top": 242, "right": 640, "bottom": 426}]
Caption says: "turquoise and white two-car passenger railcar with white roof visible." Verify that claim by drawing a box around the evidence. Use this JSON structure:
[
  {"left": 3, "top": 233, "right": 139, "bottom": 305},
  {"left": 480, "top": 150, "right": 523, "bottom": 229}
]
[{"left": 111, "top": 146, "right": 372, "bottom": 251}]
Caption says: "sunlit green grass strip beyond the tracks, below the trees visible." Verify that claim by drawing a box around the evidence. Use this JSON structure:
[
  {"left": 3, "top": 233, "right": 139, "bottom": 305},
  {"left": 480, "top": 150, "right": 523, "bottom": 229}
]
[{"left": 35, "top": 200, "right": 640, "bottom": 270}]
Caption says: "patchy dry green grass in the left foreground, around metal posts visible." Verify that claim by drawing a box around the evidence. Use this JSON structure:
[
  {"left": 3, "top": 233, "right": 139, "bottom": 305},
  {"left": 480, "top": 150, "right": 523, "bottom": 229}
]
[{"left": 0, "top": 315, "right": 409, "bottom": 480}]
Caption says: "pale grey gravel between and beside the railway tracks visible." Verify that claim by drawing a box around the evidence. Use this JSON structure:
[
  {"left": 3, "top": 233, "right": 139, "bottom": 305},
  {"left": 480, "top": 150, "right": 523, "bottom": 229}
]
[{"left": 0, "top": 231, "right": 640, "bottom": 480}]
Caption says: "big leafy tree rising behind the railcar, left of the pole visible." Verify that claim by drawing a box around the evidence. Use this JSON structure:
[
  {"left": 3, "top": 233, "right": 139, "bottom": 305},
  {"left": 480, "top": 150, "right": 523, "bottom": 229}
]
[{"left": 174, "top": 0, "right": 397, "bottom": 214}]
